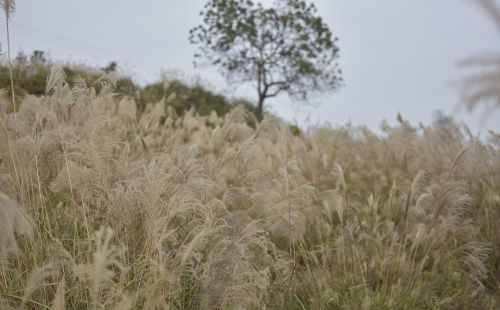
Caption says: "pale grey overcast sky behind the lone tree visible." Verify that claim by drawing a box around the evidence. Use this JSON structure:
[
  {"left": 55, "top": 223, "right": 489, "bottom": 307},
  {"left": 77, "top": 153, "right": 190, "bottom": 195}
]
[{"left": 0, "top": 0, "right": 500, "bottom": 135}]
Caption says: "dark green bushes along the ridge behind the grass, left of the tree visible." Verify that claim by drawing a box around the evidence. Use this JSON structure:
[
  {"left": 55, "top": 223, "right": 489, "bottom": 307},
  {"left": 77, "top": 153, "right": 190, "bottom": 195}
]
[{"left": 0, "top": 51, "right": 255, "bottom": 119}]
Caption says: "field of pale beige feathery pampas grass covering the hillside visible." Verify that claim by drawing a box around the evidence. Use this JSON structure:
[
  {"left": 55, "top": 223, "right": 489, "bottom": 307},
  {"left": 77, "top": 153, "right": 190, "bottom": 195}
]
[{"left": 0, "top": 69, "right": 500, "bottom": 309}]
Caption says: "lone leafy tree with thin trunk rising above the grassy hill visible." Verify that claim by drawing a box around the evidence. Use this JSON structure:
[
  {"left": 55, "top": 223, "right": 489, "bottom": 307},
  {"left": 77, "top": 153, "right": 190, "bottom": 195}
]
[{"left": 189, "top": 0, "right": 342, "bottom": 121}]
